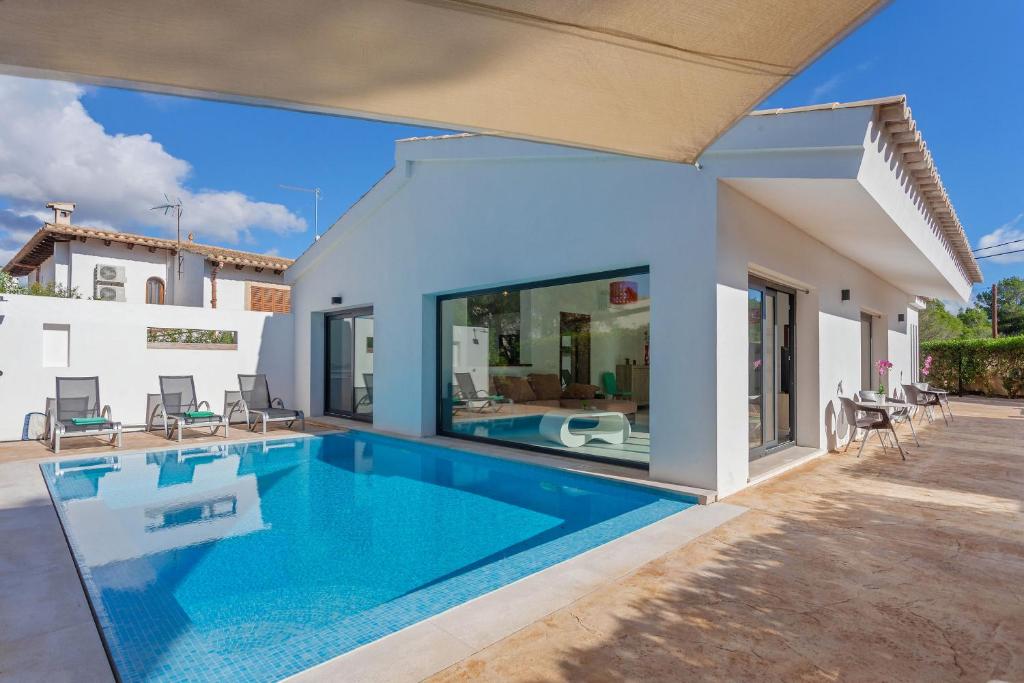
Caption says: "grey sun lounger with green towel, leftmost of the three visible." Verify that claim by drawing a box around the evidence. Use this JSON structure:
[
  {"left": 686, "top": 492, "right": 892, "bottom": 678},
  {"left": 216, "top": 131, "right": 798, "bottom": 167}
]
[{"left": 49, "top": 377, "right": 124, "bottom": 453}]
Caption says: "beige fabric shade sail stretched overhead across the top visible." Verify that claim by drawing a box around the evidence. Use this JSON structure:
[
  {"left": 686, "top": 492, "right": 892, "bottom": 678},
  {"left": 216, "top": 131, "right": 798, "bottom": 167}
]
[{"left": 0, "top": 0, "right": 883, "bottom": 162}]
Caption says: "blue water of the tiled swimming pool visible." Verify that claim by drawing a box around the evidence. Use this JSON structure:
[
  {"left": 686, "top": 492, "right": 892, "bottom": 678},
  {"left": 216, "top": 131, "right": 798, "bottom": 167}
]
[{"left": 42, "top": 432, "right": 693, "bottom": 681}]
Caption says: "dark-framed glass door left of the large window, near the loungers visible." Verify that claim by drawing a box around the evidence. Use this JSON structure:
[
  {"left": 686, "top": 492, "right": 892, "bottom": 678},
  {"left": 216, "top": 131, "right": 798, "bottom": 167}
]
[{"left": 324, "top": 308, "right": 374, "bottom": 421}]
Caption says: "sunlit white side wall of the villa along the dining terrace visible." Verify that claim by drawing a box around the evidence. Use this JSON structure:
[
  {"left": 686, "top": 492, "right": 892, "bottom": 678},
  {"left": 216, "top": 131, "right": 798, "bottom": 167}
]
[{"left": 717, "top": 184, "right": 915, "bottom": 494}]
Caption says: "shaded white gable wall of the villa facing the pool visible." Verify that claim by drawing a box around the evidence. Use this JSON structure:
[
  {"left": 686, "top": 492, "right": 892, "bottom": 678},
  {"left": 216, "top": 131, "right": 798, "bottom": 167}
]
[{"left": 288, "top": 138, "right": 716, "bottom": 487}]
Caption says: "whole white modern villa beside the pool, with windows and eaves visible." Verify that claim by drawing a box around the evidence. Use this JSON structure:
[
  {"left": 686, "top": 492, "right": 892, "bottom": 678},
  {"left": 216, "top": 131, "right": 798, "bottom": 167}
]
[{"left": 286, "top": 97, "right": 981, "bottom": 495}]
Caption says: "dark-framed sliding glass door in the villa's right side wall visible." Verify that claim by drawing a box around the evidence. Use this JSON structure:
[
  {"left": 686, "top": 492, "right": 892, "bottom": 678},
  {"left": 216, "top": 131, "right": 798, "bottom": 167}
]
[{"left": 746, "top": 278, "right": 796, "bottom": 460}]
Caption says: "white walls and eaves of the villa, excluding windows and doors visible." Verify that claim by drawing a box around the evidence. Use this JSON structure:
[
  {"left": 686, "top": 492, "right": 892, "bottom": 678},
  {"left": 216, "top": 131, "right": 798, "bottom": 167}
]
[{"left": 288, "top": 111, "right": 969, "bottom": 496}]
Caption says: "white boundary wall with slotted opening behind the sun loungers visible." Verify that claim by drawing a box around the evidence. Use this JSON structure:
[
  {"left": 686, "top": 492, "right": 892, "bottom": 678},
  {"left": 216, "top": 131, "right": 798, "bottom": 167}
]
[{"left": 0, "top": 294, "right": 294, "bottom": 440}]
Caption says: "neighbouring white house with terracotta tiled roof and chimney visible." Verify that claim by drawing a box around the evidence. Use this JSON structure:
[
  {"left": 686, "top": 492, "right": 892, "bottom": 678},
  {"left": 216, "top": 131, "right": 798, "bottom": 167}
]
[{"left": 4, "top": 202, "right": 292, "bottom": 312}]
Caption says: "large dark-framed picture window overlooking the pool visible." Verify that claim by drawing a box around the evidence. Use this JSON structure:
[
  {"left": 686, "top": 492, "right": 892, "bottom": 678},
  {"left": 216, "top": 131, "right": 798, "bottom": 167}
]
[{"left": 438, "top": 269, "right": 650, "bottom": 466}]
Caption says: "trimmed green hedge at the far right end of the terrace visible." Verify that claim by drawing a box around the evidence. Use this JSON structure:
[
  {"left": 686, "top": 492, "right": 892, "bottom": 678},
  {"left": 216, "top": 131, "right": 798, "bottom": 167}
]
[{"left": 921, "top": 336, "right": 1024, "bottom": 398}]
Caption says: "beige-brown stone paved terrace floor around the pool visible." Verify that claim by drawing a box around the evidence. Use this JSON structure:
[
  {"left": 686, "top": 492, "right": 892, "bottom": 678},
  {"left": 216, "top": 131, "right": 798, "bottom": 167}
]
[{"left": 0, "top": 399, "right": 1024, "bottom": 682}]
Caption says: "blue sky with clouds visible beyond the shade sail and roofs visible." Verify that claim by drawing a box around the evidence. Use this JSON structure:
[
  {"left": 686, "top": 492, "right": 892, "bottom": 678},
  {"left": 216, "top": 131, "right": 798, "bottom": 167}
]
[{"left": 0, "top": 0, "right": 1024, "bottom": 305}]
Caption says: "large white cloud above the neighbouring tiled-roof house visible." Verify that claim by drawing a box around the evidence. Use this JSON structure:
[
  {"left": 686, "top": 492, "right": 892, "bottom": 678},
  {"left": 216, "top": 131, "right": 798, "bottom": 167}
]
[{"left": 0, "top": 76, "right": 306, "bottom": 248}]
